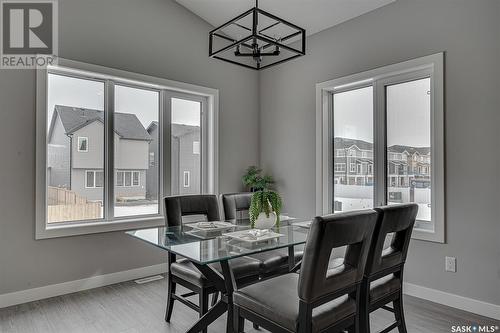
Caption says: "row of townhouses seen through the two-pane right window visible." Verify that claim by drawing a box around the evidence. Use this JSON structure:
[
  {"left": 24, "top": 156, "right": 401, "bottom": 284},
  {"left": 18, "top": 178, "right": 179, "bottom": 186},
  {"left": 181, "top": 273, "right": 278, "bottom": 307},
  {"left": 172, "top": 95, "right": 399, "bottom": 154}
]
[{"left": 334, "top": 137, "right": 431, "bottom": 188}]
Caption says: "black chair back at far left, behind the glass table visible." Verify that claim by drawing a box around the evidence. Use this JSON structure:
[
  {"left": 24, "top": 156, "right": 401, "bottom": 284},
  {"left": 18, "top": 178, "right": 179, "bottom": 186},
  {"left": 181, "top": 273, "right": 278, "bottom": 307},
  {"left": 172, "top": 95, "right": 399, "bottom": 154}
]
[{"left": 164, "top": 194, "right": 220, "bottom": 227}]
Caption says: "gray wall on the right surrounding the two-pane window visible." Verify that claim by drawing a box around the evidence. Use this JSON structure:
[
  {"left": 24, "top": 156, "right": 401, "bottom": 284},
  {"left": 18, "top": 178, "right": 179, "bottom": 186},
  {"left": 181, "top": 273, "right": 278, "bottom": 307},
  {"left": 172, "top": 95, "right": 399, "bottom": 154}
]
[{"left": 260, "top": 0, "right": 500, "bottom": 304}]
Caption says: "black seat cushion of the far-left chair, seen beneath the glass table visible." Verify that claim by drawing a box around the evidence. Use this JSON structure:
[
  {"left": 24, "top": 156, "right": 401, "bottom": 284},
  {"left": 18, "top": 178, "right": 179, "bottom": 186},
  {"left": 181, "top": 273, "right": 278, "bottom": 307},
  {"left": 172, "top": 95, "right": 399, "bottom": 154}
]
[{"left": 170, "top": 257, "right": 261, "bottom": 287}]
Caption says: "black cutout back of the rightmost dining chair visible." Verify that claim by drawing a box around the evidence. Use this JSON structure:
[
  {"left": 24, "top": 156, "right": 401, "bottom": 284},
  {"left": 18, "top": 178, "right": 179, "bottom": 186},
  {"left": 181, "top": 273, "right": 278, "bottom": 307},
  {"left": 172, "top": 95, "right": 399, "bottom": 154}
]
[{"left": 365, "top": 203, "right": 418, "bottom": 276}]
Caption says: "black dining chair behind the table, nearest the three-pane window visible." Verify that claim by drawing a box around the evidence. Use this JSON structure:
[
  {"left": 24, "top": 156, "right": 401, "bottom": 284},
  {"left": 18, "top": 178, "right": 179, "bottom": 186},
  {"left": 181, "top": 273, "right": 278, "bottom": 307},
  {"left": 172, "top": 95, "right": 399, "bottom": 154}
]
[{"left": 164, "top": 195, "right": 261, "bottom": 332}]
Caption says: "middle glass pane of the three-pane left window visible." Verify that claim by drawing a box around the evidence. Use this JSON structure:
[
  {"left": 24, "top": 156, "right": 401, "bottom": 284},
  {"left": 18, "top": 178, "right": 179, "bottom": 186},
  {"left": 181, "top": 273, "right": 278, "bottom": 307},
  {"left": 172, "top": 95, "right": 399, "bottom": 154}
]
[{"left": 113, "top": 84, "right": 160, "bottom": 218}]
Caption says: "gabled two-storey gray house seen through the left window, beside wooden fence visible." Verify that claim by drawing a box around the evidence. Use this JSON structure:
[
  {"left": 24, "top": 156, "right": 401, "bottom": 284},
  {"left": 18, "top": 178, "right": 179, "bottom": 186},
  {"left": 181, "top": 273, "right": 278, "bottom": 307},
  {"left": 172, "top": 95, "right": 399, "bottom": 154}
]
[{"left": 47, "top": 105, "right": 151, "bottom": 201}]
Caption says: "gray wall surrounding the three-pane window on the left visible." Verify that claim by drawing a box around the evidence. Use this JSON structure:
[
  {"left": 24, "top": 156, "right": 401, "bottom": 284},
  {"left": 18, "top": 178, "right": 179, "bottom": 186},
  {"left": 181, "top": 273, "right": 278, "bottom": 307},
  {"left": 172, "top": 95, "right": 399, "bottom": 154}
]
[{"left": 0, "top": 0, "right": 259, "bottom": 294}]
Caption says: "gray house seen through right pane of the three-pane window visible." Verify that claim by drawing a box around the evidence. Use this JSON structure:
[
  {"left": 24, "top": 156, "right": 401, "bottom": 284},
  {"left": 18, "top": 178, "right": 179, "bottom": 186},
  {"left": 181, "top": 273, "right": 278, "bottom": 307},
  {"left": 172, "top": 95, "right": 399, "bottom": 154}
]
[{"left": 146, "top": 121, "right": 201, "bottom": 200}]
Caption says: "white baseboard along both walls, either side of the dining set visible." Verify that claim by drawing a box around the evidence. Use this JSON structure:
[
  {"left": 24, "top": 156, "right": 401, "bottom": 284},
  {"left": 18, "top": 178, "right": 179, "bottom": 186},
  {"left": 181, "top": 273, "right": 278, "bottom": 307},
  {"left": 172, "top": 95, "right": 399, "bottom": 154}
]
[{"left": 0, "top": 264, "right": 500, "bottom": 320}]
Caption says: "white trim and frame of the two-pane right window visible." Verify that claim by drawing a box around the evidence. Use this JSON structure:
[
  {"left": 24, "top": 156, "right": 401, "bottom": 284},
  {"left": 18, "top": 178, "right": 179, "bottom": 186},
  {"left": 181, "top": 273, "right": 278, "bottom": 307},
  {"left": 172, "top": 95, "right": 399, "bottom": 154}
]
[{"left": 316, "top": 53, "right": 445, "bottom": 243}]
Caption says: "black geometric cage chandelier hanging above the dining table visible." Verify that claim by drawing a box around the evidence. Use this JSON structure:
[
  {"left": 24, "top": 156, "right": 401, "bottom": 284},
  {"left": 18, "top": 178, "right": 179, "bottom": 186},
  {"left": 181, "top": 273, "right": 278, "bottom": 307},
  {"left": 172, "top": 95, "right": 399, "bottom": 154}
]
[{"left": 209, "top": 0, "right": 306, "bottom": 70}]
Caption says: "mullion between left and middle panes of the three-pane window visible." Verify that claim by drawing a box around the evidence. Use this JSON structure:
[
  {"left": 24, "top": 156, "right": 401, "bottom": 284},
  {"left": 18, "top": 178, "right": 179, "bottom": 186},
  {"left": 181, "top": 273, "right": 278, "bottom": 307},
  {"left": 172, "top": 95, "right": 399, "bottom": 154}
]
[{"left": 104, "top": 80, "right": 115, "bottom": 220}]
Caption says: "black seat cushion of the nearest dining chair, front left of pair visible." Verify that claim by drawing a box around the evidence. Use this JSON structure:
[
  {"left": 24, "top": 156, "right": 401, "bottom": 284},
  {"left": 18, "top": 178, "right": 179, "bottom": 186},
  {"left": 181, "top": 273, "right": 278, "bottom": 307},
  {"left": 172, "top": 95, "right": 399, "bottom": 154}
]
[{"left": 233, "top": 274, "right": 356, "bottom": 332}]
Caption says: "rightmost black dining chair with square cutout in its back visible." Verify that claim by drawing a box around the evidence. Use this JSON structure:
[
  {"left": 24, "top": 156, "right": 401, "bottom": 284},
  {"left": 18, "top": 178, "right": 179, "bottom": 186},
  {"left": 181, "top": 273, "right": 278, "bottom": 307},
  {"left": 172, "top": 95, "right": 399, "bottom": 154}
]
[{"left": 361, "top": 204, "right": 418, "bottom": 333}]
